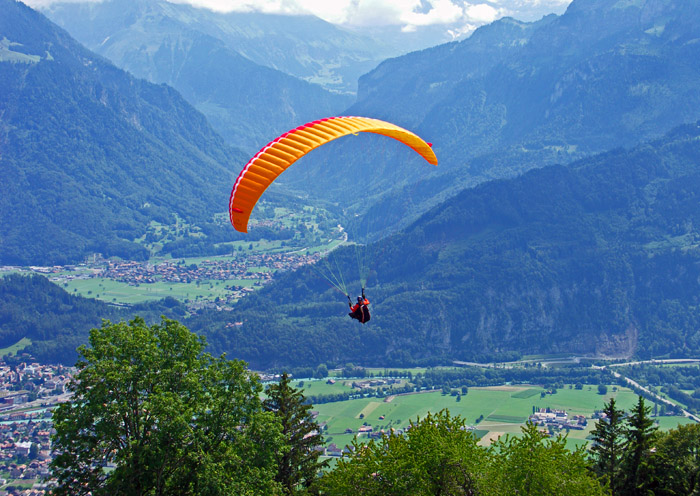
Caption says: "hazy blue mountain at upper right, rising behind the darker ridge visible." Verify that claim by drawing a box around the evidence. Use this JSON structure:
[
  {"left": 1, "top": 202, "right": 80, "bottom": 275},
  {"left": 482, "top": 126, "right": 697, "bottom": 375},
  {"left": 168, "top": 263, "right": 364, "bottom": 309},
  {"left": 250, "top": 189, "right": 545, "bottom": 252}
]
[{"left": 283, "top": 0, "right": 700, "bottom": 236}]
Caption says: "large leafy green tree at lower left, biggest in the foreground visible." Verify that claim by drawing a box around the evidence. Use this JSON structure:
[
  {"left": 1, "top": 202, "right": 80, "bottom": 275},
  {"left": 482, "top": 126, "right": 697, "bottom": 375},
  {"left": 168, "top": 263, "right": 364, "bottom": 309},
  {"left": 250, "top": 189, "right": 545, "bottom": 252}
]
[{"left": 52, "top": 317, "right": 281, "bottom": 495}]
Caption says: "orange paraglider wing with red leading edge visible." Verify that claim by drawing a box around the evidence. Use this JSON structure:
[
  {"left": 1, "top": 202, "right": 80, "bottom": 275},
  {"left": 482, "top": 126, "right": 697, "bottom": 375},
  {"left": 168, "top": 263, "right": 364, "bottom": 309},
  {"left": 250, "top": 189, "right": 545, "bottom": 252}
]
[{"left": 229, "top": 117, "right": 437, "bottom": 232}]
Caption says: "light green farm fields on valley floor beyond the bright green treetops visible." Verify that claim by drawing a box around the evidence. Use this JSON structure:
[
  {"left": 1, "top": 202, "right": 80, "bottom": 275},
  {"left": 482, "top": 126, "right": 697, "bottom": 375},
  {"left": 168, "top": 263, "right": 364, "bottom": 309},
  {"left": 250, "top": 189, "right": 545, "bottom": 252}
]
[{"left": 314, "top": 381, "right": 690, "bottom": 454}]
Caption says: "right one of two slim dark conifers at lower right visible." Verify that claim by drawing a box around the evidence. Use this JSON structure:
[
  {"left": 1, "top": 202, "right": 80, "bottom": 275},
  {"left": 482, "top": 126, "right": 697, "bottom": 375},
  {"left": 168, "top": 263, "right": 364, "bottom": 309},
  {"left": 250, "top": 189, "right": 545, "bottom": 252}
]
[{"left": 620, "top": 396, "right": 658, "bottom": 496}]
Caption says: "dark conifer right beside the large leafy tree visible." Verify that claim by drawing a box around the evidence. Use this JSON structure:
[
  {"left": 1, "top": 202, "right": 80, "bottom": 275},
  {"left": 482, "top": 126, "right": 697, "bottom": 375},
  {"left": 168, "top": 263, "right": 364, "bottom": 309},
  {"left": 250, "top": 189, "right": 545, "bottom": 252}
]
[{"left": 263, "top": 372, "right": 327, "bottom": 494}]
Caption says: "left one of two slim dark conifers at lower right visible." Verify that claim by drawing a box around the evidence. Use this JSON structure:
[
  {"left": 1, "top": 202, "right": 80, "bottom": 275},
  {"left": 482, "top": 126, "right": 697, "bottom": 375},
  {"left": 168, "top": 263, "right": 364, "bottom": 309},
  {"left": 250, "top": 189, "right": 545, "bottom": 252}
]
[{"left": 591, "top": 398, "right": 625, "bottom": 496}]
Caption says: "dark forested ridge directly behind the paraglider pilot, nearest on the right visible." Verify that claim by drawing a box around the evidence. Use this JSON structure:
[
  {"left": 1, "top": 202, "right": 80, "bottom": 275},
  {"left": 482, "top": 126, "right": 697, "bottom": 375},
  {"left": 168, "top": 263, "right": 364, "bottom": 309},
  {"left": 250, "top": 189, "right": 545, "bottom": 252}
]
[{"left": 191, "top": 124, "right": 700, "bottom": 367}]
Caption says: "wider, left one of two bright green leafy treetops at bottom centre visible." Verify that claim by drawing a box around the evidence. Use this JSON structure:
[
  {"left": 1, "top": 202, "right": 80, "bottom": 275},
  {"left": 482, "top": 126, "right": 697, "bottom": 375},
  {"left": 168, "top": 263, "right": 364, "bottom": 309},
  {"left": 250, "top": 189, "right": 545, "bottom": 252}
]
[{"left": 321, "top": 410, "right": 489, "bottom": 496}]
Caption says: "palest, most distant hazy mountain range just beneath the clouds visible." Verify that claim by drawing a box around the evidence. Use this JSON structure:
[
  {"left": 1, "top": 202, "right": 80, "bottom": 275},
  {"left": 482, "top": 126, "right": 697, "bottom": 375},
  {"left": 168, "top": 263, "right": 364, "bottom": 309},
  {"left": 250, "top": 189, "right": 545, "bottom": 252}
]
[{"left": 42, "top": 0, "right": 442, "bottom": 94}]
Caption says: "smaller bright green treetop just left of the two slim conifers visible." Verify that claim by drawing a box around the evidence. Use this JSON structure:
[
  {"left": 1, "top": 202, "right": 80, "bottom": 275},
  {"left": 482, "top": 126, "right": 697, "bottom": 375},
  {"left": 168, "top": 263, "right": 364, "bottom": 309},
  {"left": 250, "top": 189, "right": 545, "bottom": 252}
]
[{"left": 485, "top": 422, "right": 605, "bottom": 496}]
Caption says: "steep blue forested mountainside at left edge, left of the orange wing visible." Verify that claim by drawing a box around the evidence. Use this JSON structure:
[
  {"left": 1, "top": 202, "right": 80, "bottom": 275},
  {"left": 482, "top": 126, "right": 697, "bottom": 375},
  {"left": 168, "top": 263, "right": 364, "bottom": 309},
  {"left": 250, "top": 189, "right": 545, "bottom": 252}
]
[{"left": 0, "top": 0, "right": 245, "bottom": 264}]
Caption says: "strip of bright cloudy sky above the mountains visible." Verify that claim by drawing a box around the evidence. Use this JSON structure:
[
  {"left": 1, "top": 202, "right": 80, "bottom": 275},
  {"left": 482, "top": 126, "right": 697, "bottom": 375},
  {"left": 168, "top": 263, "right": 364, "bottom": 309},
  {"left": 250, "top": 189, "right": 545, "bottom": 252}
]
[{"left": 25, "top": 0, "right": 571, "bottom": 38}]
